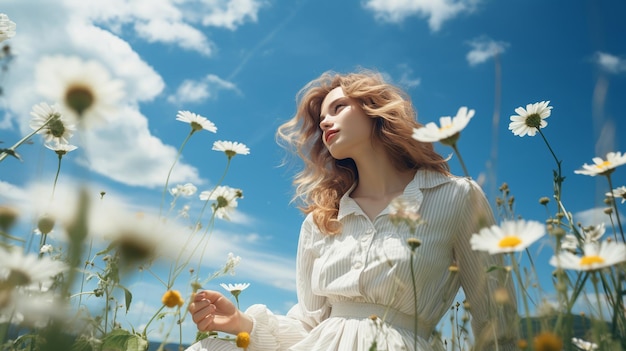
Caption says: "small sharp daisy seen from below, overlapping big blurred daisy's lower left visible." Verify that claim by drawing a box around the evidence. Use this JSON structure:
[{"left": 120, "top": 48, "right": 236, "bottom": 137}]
[{"left": 30, "top": 102, "right": 76, "bottom": 144}]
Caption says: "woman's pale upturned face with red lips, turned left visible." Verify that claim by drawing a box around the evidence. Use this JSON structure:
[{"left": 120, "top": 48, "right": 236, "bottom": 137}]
[{"left": 320, "top": 87, "right": 374, "bottom": 160}]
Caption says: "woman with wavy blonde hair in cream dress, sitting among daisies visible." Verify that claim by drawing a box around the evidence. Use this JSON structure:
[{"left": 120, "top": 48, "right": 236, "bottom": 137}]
[{"left": 189, "top": 71, "right": 517, "bottom": 351}]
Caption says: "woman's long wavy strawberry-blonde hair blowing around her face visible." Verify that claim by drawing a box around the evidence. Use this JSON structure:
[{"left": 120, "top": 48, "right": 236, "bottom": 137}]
[{"left": 276, "top": 70, "right": 449, "bottom": 235}]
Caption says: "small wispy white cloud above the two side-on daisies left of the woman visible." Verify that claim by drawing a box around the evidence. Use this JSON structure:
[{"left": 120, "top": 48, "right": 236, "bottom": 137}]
[{"left": 167, "top": 74, "right": 239, "bottom": 104}]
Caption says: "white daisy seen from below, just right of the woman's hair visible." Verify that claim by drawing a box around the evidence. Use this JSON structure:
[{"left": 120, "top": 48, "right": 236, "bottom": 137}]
[{"left": 413, "top": 106, "right": 474, "bottom": 145}]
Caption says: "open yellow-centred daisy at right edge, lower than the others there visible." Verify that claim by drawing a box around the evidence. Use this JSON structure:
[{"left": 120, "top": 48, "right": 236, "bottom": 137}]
[{"left": 550, "top": 241, "right": 626, "bottom": 271}]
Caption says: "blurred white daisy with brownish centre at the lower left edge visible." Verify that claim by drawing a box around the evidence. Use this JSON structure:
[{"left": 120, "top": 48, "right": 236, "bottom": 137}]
[{"left": 0, "top": 248, "right": 67, "bottom": 291}]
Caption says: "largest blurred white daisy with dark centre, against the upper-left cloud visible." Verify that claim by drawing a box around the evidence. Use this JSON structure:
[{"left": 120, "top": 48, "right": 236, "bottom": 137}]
[{"left": 35, "top": 56, "right": 123, "bottom": 126}]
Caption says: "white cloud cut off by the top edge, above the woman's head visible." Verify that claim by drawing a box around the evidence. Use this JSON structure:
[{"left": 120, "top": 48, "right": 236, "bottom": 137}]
[{"left": 364, "top": 0, "right": 479, "bottom": 31}]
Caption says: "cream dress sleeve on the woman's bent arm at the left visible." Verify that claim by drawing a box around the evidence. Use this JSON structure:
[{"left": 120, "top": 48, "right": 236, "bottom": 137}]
[{"left": 245, "top": 215, "right": 330, "bottom": 351}]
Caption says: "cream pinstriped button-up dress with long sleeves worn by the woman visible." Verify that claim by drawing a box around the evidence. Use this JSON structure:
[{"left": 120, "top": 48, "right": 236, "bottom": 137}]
[{"left": 188, "top": 170, "right": 516, "bottom": 351}]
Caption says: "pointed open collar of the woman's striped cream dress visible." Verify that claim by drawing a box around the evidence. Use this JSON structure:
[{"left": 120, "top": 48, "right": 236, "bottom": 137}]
[{"left": 337, "top": 170, "right": 452, "bottom": 220}]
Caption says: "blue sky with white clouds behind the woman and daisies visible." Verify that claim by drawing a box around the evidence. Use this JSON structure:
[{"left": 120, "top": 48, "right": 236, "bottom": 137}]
[{"left": 0, "top": 0, "right": 626, "bottom": 346}]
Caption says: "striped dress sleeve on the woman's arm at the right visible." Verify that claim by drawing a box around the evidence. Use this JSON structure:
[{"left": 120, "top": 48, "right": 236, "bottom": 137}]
[{"left": 454, "top": 179, "right": 518, "bottom": 351}]
